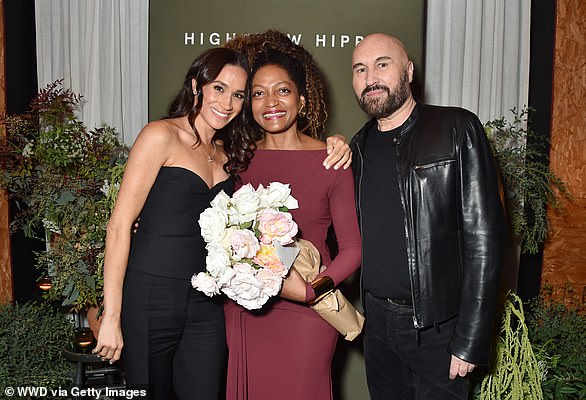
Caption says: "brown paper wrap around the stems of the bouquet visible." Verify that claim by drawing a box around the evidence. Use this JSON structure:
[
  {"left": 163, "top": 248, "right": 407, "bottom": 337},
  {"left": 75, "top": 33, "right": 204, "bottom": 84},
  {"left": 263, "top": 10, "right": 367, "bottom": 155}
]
[{"left": 293, "top": 239, "right": 364, "bottom": 341}]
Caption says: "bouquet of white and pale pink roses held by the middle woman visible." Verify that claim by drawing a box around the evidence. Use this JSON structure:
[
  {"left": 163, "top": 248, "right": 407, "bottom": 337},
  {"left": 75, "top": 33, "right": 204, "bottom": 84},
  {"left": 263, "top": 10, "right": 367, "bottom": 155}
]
[{"left": 191, "top": 182, "right": 299, "bottom": 310}]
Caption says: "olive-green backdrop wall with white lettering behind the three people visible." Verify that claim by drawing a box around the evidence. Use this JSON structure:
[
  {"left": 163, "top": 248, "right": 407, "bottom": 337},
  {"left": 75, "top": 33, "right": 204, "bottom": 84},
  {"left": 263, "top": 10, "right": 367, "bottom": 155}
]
[{"left": 149, "top": 0, "right": 425, "bottom": 400}]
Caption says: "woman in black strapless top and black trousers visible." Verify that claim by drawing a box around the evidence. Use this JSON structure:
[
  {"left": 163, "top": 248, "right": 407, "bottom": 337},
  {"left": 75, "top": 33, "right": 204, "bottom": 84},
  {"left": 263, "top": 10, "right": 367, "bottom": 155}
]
[{"left": 95, "top": 48, "right": 251, "bottom": 400}]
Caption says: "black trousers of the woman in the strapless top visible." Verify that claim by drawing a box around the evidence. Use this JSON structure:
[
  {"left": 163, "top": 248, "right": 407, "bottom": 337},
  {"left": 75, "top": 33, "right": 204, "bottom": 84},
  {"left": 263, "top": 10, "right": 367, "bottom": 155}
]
[{"left": 122, "top": 268, "right": 226, "bottom": 400}]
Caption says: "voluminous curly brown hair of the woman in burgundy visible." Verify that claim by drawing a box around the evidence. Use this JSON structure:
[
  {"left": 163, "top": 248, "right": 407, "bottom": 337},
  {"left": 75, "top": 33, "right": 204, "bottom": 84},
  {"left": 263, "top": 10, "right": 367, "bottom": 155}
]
[{"left": 225, "top": 30, "right": 328, "bottom": 140}]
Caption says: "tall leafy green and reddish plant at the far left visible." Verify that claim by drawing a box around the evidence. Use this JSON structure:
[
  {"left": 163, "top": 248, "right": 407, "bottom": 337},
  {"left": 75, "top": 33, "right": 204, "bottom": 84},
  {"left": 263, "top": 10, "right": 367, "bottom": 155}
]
[{"left": 0, "top": 81, "right": 128, "bottom": 310}]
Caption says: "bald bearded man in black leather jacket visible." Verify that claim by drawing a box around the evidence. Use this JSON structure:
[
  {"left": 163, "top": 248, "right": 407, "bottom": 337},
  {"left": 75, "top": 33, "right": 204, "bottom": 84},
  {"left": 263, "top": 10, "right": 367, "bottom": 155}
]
[{"left": 351, "top": 34, "right": 507, "bottom": 400}]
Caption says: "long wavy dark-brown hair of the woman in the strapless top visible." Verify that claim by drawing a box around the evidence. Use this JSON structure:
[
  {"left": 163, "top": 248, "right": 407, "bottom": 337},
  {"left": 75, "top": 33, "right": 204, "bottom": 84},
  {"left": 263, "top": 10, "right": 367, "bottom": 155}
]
[{"left": 164, "top": 47, "right": 254, "bottom": 177}]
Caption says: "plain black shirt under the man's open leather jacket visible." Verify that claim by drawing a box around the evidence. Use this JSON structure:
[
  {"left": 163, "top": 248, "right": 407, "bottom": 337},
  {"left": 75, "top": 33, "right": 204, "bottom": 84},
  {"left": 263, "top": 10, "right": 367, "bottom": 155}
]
[{"left": 361, "top": 124, "right": 411, "bottom": 300}]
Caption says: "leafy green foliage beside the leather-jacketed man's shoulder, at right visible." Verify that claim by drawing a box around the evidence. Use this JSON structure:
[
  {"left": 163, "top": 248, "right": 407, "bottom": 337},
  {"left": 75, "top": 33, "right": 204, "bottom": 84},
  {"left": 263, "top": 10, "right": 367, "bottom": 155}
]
[{"left": 484, "top": 108, "right": 570, "bottom": 254}]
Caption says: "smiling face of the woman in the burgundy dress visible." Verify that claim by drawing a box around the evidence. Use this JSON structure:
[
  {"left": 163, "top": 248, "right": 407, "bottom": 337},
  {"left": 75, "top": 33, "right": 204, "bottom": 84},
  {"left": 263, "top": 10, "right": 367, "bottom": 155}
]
[{"left": 251, "top": 64, "right": 305, "bottom": 133}]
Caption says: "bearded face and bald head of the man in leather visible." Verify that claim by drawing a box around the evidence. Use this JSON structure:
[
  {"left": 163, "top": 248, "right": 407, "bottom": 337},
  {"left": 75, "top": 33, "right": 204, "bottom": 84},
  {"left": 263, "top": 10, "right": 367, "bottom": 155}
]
[{"left": 352, "top": 34, "right": 413, "bottom": 118}]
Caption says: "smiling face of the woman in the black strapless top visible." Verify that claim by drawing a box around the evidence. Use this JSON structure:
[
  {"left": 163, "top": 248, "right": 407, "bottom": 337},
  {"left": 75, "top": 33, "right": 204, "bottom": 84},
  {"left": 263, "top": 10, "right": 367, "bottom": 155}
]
[{"left": 192, "top": 65, "right": 247, "bottom": 132}]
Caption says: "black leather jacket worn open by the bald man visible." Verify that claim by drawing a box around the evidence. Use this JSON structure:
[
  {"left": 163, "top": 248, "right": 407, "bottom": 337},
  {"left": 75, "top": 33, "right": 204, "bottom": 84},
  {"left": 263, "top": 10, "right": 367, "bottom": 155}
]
[{"left": 351, "top": 103, "right": 507, "bottom": 365}]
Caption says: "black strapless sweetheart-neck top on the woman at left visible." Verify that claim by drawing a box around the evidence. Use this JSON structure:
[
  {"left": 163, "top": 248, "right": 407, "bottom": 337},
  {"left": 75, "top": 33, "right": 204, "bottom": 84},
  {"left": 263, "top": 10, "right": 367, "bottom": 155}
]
[{"left": 128, "top": 167, "right": 234, "bottom": 279}]
